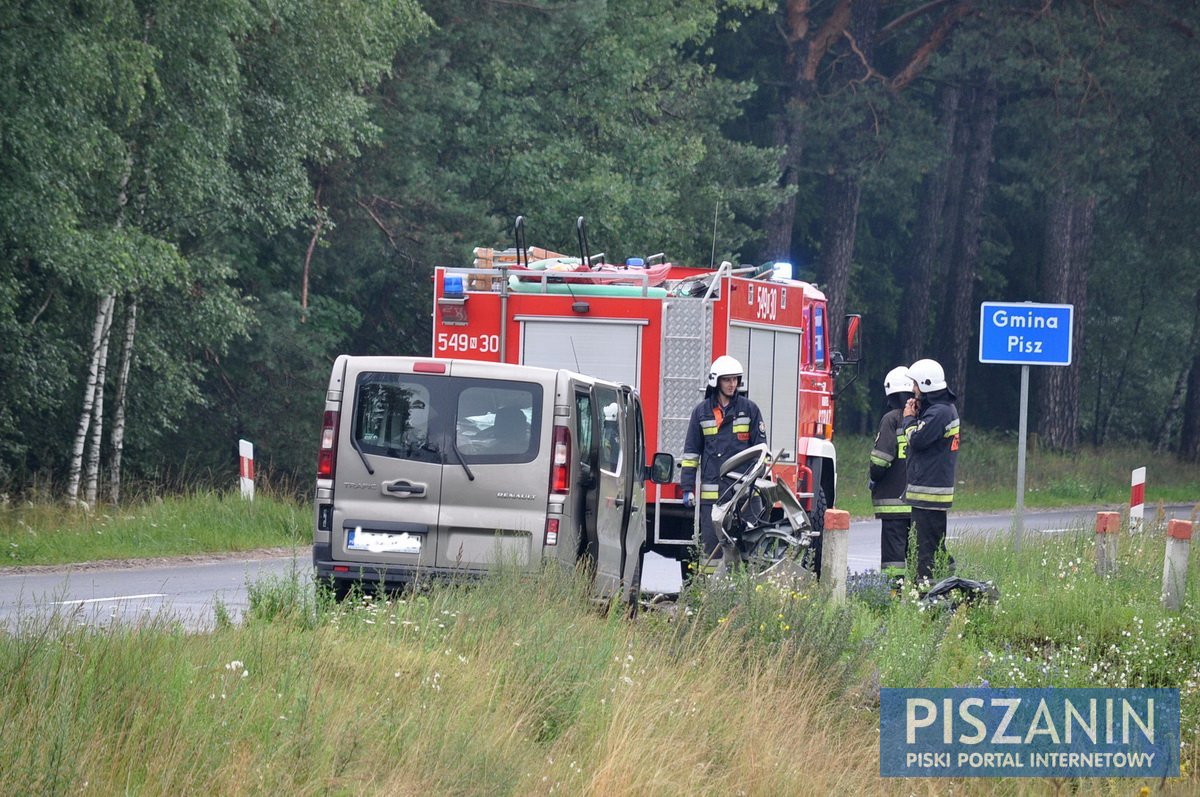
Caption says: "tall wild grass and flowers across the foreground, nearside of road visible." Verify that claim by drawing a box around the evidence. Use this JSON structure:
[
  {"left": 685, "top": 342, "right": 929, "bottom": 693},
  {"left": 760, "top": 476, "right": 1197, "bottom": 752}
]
[{"left": 0, "top": 529, "right": 1200, "bottom": 796}]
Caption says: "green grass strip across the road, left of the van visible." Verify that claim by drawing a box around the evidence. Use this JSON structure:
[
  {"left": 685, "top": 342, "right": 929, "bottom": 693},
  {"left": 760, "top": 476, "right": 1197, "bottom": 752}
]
[{"left": 0, "top": 491, "right": 304, "bottom": 567}]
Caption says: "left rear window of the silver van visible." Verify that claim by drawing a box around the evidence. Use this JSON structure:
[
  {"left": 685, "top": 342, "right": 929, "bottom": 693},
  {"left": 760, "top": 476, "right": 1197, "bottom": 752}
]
[{"left": 354, "top": 373, "right": 442, "bottom": 462}]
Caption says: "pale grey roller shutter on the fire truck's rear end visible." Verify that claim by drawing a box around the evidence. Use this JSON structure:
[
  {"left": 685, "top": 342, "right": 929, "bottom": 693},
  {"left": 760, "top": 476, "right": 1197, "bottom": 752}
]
[{"left": 521, "top": 318, "right": 642, "bottom": 388}]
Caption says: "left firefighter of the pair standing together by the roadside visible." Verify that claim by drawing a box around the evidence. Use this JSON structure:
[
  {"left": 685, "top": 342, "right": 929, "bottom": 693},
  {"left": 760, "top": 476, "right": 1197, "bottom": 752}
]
[{"left": 868, "top": 366, "right": 913, "bottom": 580}]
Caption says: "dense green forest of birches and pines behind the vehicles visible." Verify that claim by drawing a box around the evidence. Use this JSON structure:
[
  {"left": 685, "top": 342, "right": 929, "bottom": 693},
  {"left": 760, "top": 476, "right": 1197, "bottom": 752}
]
[{"left": 0, "top": 0, "right": 1200, "bottom": 503}]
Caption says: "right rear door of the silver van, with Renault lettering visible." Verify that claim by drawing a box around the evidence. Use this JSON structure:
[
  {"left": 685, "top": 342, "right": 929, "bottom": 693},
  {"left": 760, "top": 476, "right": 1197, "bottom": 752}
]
[{"left": 436, "top": 360, "right": 556, "bottom": 569}]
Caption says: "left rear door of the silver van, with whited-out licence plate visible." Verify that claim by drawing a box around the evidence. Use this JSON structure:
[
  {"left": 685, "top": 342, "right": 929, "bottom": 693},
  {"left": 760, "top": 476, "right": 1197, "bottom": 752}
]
[{"left": 331, "top": 358, "right": 450, "bottom": 567}]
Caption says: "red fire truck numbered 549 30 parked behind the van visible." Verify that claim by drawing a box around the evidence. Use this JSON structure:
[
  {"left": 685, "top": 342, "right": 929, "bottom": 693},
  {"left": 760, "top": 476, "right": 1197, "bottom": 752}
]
[{"left": 433, "top": 218, "right": 860, "bottom": 561}]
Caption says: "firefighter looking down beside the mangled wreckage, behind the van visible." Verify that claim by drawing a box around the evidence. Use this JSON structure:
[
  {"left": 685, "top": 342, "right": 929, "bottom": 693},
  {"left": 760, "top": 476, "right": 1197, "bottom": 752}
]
[{"left": 679, "top": 354, "right": 767, "bottom": 562}]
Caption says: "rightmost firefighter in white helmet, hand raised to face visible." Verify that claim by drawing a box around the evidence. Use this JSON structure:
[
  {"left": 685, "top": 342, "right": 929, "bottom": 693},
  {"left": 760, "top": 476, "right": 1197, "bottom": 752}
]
[{"left": 904, "top": 360, "right": 959, "bottom": 580}]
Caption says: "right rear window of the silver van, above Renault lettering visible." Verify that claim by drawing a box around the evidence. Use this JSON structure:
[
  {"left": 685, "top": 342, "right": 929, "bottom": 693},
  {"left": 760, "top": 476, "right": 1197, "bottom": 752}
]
[{"left": 455, "top": 379, "right": 541, "bottom": 463}]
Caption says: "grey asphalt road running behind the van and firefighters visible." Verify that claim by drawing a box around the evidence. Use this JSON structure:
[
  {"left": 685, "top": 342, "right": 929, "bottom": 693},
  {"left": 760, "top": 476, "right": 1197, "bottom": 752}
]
[{"left": 0, "top": 505, "right": 1193, "bottom": 630}]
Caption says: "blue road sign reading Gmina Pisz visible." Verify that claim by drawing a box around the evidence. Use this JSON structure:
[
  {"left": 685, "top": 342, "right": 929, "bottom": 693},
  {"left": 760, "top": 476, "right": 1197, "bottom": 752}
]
[{"left": 979, "top": 301, "right": 1075, "bottom": 365}]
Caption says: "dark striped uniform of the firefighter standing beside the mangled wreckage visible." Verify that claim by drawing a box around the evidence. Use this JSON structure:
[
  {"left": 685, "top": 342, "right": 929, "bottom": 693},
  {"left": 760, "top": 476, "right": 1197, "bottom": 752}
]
[{"left": 679, "top": 394, "right": 767, "bottom": 559}]
